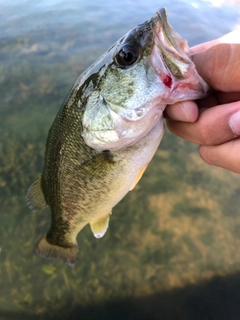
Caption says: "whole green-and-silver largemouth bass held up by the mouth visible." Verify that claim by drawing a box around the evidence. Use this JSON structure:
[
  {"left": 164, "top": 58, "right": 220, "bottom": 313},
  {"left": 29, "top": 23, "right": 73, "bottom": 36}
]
[{"left": 26, "top": 8, "right": 208, "bottom": 266}]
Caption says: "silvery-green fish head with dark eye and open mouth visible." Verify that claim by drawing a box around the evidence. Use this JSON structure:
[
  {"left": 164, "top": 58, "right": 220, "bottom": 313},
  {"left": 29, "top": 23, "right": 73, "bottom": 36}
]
[{"left": 82, "top": 8, "right": 208, "bottom": 151}]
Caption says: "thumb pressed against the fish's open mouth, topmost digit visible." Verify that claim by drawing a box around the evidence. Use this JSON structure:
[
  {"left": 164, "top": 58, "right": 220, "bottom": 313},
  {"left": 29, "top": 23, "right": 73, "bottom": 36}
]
[{"left": 192, "top": 43, "right": 240, "bottom": 92}]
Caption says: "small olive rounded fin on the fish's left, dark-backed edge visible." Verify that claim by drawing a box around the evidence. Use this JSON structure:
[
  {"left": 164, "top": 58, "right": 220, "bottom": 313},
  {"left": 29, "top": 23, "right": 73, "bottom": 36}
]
[{"left": 26, "top": 177, "right": 48, "bottom": 211}]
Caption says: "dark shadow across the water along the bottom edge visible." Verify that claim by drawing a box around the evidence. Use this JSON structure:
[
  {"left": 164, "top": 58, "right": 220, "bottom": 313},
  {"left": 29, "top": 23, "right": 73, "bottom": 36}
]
[{"left": 0, "top": 273, "right": 240, "bottom": 320}]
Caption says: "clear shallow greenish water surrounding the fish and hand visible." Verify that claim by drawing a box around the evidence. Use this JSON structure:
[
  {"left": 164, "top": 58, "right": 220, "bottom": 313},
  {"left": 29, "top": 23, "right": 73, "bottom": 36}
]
[{"left": 0, "top": 0, "right": 240, "bottom": 320}]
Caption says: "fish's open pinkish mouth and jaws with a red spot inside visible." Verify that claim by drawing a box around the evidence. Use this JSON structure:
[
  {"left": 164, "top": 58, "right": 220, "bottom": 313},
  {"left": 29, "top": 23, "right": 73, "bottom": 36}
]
[{"left": 149, "top": 8, "right": 209, "bottom": 104}]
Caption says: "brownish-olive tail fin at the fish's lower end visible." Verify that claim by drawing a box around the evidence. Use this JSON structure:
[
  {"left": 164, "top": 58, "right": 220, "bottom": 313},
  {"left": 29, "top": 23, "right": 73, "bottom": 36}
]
[{"left": 36, "top": 235, "right": 78, "bottom": 266}]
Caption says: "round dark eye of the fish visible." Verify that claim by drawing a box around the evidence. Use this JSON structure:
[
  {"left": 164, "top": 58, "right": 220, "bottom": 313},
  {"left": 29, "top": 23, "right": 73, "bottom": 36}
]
[{"left": 115, "top": 44, "right": 140, "bottom": 67}]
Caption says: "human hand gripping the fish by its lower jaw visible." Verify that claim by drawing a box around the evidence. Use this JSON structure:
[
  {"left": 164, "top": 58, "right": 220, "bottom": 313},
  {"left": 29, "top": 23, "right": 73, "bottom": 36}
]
[{"left": 165, "top": 30, "right": 240, "bottom": 173}]
